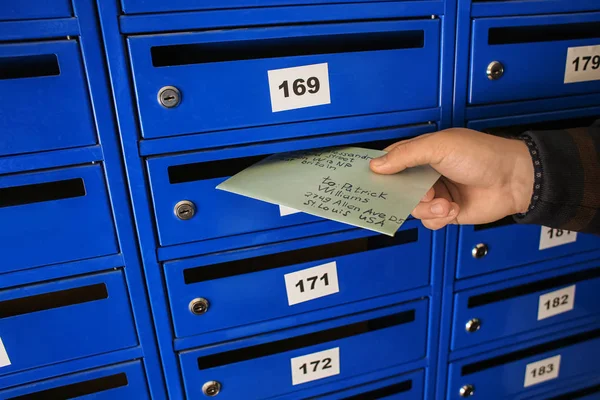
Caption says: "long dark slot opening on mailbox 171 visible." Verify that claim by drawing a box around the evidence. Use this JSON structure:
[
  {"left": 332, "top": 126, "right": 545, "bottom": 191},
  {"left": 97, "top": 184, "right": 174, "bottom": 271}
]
[{"left": 183, "top": 228, "right": 419, "bottom": 285}]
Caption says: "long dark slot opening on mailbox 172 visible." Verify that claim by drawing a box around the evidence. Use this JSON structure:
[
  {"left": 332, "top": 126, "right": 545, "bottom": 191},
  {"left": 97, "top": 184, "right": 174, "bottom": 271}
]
[{"left": 198, "top": 309, "right": 416, "bottom": 370}]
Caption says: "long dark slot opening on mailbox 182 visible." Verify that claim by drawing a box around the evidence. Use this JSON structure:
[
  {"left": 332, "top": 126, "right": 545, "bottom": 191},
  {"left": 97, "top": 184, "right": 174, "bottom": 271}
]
[{"left": 468, "top": 267, "right": 600, "bottom": 308}]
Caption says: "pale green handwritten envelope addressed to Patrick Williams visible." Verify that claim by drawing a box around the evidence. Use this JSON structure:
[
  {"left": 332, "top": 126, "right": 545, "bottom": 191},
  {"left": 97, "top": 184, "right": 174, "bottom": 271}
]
[{"left": 217, "top": 147, "right": 440, "bottom": 236}]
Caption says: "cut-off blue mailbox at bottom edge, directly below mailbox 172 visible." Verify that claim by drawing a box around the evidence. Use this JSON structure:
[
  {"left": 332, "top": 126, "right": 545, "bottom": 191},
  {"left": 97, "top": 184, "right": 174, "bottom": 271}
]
[{"left": 302, "top": 370, "right": 425, "bottom": 400}]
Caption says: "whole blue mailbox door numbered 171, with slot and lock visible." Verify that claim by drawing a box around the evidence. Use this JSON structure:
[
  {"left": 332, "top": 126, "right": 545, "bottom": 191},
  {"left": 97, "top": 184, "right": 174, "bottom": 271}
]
[{"left": 165, "top": 221, "right": 431, "bottom": 337}]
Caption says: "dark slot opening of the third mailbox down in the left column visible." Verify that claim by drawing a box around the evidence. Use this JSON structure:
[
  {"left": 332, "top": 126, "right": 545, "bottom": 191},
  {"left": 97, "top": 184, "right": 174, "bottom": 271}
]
[{"left": 0, "top": 283, "right": 108, "bottom": 319}]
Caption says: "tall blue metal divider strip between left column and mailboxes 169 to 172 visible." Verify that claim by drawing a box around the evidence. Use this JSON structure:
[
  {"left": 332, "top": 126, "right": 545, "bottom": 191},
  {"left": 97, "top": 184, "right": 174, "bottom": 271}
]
[{"left": 74, "top": 0, "right": 166, "bottom": 394}]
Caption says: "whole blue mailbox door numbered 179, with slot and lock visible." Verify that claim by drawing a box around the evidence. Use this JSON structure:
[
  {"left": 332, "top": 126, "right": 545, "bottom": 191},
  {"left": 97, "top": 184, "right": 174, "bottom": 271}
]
[{"left": 469, "top": 13, "right": 600, "bottom": 104}]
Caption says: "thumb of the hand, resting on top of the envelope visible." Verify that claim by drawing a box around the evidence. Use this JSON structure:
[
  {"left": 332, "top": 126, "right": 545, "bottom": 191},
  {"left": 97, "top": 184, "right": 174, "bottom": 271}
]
[{"left": 370, "top": 134, "right": 437, "bottom": 174}]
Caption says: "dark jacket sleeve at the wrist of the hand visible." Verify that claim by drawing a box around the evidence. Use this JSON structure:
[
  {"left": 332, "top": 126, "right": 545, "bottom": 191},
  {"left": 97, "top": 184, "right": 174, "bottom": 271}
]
[{"left": 515, "top": 120, "right": 600, "bottom": 234}]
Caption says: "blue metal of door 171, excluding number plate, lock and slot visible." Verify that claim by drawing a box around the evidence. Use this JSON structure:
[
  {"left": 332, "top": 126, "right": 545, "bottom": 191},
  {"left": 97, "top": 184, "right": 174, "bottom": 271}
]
[{"left": 165, "top": 221, "right": 431, "bottom": 336}]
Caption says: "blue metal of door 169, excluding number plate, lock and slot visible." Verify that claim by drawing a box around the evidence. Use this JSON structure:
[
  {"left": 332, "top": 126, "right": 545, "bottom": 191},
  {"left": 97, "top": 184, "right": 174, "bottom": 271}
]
[{"left": 128, "top": 19, "right": 440, "bottom": 138}]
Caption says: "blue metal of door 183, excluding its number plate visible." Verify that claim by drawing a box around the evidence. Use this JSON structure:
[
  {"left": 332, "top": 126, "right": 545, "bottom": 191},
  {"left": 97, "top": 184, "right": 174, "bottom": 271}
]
[{"left": 446, "top": 324, "right": 600, "bottom": 399}]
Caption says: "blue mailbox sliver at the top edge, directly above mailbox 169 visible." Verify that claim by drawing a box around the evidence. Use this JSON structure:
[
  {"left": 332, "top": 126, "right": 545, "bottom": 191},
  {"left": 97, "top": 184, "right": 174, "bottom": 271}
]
[{"left": 121, "top": 0, "right": 422, "bottom": 14}]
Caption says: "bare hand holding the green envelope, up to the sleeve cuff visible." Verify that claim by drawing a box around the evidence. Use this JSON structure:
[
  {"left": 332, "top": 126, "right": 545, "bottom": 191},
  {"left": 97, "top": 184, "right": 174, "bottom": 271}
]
[{"left": 370, "top": 128, "right": 534, "bottom": 230}]
